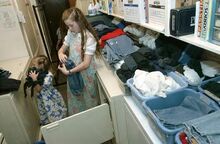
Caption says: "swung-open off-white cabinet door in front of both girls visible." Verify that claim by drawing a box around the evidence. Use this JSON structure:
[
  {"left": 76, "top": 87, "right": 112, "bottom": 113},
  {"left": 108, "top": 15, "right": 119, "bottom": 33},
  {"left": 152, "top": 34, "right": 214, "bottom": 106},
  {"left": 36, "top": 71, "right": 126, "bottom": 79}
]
[{"left": 41, "top": 104, "right": 113, "bottom": 144}]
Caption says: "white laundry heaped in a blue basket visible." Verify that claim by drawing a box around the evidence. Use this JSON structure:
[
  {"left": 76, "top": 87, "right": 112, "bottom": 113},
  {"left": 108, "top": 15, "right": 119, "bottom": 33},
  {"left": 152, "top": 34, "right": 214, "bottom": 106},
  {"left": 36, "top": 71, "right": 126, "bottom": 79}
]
[{"left": 133, "top": 70, "right": 180, "bottom": 97}]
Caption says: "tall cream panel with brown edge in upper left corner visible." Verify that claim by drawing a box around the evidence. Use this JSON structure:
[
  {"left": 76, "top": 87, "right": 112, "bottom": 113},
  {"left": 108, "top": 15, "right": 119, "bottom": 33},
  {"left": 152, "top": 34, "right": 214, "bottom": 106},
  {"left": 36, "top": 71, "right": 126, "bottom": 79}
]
[{"left": 0, "top": 0, "right": 43, "bottom": 61}]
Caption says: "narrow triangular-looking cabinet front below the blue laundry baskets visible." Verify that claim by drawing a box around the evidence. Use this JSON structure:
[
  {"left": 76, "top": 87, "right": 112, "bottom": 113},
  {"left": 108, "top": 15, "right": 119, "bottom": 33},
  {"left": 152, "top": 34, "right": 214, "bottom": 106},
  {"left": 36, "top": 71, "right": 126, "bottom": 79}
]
[{"left": 125, "top": 105, "right": 148, "bottom": 144}]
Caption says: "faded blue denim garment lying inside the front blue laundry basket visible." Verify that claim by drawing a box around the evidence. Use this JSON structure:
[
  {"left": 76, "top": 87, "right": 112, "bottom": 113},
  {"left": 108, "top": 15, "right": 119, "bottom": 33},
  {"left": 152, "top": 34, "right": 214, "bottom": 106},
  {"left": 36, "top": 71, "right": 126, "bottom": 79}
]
[{"left": 154, "top": 95, "right": 216, "bottom": 126}]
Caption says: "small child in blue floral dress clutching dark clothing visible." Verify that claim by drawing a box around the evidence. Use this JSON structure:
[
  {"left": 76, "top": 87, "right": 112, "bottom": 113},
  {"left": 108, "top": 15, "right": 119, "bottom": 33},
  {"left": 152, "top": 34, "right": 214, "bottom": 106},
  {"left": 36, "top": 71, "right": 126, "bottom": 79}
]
[{"left": 26, "top": 55, "right": 67, "bottom": 125}]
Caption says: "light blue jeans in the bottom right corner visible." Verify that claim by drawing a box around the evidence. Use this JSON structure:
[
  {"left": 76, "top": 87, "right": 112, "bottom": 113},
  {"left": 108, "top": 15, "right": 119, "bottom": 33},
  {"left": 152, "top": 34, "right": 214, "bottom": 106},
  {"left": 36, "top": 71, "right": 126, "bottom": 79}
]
[{"left": 185, "top": 111, "right": 220, "bottom": 144}]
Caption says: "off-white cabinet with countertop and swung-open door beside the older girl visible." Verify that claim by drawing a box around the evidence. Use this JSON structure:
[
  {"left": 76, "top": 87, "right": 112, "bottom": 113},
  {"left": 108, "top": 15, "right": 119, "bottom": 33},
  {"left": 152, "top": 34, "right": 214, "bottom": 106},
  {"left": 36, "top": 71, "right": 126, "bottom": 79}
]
[{"left": 41, "top": 60, "right": 126, "bottom": 144}]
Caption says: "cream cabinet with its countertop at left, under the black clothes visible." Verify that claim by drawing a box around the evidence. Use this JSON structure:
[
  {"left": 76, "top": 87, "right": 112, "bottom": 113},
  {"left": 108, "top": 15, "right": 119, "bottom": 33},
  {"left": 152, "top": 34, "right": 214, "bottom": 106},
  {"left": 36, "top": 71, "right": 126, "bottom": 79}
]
[{"left": 0, "top": 57, "right": 40, "bottom": 144}]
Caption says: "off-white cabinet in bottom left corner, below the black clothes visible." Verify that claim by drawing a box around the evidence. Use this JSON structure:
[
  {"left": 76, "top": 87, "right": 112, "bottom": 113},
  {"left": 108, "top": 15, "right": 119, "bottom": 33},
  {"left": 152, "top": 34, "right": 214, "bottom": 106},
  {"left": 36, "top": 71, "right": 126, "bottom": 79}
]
[{"left": 0, "top": 93, "right": 40, "bottom": 144}]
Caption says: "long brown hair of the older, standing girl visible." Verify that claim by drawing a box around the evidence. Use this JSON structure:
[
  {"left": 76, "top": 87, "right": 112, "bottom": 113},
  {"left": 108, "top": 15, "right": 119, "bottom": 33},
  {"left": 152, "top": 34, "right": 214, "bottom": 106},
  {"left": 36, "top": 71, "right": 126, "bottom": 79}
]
[{"left": 62, "top": 7, "right": 101, "bottom": 60}]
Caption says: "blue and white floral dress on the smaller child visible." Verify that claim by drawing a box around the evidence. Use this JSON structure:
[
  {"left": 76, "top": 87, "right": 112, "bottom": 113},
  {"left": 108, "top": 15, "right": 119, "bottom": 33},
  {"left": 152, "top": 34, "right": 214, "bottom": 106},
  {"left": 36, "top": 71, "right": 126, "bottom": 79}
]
[{"left": 36, "top": 72, "right": 67, "bottom": 125}]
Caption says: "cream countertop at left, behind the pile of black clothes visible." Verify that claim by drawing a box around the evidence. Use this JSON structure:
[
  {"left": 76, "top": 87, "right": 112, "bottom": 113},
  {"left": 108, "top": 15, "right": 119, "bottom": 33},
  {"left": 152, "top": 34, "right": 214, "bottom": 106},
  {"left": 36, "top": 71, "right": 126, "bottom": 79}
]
[{"left": 0, "top": 57, "right": 30, "bottom": 80}]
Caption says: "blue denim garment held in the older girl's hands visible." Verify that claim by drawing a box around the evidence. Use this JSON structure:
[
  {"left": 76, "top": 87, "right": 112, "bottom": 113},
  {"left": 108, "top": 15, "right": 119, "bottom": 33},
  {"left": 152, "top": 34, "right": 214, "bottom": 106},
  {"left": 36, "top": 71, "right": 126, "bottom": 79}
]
[{"left": 65, "top": 59, "right": 84, "bottom": 95}]
